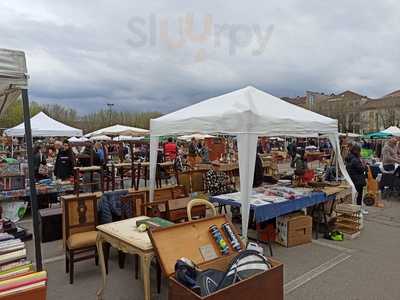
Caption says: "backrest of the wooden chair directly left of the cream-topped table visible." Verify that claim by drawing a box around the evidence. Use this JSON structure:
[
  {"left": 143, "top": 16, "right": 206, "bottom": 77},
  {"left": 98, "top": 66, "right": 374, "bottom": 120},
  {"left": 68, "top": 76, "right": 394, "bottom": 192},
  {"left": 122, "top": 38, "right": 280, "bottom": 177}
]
[{"left": 62, "top": 194, "right": 98, "bottom": 238}]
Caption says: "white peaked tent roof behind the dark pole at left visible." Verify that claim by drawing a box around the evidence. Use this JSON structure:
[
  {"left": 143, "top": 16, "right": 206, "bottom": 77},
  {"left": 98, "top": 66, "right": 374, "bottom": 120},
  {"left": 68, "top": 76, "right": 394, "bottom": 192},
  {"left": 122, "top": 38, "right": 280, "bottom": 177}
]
[{"left": 4, "top": 112, "right": 82, "bottom": 137}]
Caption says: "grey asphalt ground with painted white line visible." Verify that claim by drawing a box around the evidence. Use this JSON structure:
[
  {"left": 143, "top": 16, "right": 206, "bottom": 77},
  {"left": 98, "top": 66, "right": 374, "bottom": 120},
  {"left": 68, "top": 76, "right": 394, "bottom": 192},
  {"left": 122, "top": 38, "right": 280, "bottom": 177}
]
[{"left": 19, "top": 199, "right": 400, "bottom": 300}]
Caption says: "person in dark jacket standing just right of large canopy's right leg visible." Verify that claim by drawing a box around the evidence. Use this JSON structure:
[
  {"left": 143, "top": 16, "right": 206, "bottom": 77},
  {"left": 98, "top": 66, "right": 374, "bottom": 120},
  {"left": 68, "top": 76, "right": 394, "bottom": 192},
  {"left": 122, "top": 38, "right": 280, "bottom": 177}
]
[{"left": 346, "top": 144, "right": 366, "bottom": 205}]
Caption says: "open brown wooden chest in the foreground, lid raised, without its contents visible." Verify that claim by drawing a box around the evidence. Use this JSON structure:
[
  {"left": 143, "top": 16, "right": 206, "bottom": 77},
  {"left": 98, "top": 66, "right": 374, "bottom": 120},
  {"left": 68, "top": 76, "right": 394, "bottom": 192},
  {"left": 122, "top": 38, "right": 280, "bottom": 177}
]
[{"left": 149, "top": 216, "right": 283, "bottom": 300}]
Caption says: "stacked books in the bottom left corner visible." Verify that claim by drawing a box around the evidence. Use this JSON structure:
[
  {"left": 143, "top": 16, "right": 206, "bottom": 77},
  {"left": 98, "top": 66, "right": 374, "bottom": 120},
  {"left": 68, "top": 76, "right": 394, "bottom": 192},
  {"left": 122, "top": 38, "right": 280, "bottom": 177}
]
[{"left": 0, "top": 234, "right": 47, "bottom": 299}]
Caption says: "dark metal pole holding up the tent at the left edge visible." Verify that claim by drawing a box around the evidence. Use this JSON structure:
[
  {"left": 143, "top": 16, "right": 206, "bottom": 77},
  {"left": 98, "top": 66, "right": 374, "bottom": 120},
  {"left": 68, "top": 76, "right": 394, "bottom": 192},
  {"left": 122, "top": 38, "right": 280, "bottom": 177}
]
[{"left": 22, "top": 89, "right": 43, "bottom": 271}]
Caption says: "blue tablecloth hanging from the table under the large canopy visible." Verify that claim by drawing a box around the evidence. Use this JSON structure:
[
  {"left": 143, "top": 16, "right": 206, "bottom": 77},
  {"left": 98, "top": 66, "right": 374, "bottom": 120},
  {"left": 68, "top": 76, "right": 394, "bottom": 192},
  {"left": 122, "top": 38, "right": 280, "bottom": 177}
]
[{"left": 210, "top": 192, "right": 326, "bottom": 222}]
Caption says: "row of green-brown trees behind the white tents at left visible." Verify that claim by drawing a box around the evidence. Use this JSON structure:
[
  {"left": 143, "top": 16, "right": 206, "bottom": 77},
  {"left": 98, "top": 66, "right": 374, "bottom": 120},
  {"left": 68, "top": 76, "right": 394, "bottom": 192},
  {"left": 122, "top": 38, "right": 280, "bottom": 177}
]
[{"left": 0, "top": 100, "right": 161, "bottom": 133}]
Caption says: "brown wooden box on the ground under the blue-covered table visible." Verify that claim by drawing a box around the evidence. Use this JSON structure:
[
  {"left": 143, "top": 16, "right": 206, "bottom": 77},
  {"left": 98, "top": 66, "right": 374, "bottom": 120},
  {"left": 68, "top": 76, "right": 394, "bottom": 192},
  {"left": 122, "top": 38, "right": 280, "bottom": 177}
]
[{"left": 276, "top": 213, "right": 312, "bottom": 247}]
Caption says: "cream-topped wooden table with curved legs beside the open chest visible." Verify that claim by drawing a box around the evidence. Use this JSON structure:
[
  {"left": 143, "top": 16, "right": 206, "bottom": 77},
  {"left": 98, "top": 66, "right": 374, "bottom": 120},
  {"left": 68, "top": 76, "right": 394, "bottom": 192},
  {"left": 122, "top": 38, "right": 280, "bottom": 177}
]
[{"left": 96, "top": 216, "right": 154, "bottom": 300}]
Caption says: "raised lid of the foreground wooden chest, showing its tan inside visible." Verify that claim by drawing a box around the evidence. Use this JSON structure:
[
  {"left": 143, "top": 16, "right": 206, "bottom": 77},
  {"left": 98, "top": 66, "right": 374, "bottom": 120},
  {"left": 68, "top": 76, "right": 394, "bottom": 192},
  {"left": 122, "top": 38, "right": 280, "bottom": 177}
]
[{"left": 149, "top": 215, "right": 244, "bottom": 276}]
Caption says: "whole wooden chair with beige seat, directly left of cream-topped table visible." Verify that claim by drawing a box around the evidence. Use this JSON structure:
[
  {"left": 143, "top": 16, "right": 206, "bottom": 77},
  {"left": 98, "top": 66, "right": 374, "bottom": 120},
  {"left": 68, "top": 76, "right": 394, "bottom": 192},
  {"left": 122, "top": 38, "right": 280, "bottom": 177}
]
[{"left": 63, "top": 195, "right": 98, "bottom": 284}]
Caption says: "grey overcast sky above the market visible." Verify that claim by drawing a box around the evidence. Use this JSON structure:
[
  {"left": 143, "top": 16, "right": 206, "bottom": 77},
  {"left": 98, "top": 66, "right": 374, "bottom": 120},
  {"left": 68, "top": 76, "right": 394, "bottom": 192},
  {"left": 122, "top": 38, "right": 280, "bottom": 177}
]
[{"left": 0, "top": 0, "right": 400, "bottom": 113}]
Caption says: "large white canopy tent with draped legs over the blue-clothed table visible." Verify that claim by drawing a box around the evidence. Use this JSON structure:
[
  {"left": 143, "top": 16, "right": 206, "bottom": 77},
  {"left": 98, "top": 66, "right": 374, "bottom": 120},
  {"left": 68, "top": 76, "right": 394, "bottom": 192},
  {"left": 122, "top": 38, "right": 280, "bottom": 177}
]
[{"left": 150, "top": 86, "right": 356, "bottom": 236}]
